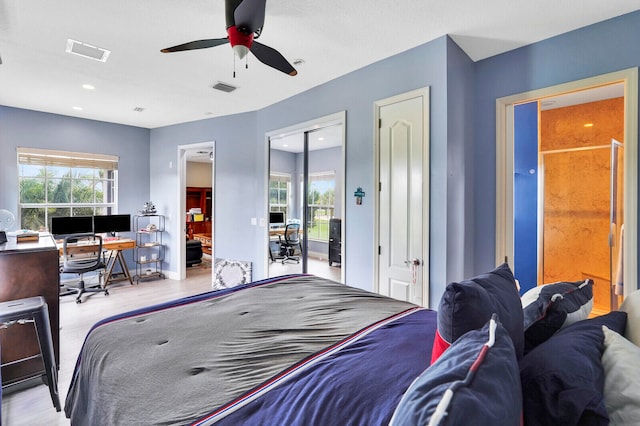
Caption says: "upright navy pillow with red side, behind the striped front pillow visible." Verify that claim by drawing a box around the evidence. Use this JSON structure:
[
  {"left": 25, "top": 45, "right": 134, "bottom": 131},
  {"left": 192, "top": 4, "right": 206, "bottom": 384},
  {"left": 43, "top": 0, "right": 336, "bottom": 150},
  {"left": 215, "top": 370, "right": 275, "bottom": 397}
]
[{"left": 431, "top": 263, "right": 524, "bottom": 363}]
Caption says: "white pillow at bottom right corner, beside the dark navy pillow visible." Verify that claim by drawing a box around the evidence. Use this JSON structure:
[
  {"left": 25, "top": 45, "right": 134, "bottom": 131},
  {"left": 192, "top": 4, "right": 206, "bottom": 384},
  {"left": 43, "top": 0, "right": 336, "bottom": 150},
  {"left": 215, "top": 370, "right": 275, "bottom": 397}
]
[{"left": 602, "top": 326, "right": 640, "bottom": 425}]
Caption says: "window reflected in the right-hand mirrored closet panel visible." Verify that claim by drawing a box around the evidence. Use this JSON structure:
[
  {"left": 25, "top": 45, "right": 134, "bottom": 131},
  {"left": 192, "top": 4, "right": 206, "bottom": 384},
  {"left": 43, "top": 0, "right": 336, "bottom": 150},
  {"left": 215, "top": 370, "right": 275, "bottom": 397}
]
[{"left": 307, "top": 171, "right": 336, "bottom": 241}]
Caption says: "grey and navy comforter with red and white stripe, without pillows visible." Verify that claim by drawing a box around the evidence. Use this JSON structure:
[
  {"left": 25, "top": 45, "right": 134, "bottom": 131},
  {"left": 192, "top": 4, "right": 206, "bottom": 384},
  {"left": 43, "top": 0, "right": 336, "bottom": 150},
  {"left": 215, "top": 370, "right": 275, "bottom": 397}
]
[{"left": 65, "top": 275, "right": 436, "bottom": 425}]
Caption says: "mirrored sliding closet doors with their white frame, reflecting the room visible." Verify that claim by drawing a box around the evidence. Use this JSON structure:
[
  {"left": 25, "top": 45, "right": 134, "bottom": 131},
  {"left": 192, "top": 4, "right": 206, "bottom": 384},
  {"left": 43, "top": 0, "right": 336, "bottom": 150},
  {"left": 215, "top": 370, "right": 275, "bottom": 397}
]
[{"left": 265, "top": 112, "right": 346, "bottom": 282}]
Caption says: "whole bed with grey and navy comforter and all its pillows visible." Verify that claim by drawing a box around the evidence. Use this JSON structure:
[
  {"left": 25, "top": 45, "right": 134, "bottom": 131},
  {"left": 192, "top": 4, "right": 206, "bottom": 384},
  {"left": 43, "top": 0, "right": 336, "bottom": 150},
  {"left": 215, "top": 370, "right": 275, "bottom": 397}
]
[{"left": 65, "top": 264, "right": 640, "bottom": 426}]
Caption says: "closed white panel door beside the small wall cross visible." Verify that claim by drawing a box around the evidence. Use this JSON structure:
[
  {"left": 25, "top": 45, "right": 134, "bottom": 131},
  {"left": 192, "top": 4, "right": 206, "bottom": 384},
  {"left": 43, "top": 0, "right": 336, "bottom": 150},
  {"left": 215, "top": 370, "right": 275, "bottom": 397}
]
[{"left": 376, "top": 89, "right": 429, "bottom": 306}]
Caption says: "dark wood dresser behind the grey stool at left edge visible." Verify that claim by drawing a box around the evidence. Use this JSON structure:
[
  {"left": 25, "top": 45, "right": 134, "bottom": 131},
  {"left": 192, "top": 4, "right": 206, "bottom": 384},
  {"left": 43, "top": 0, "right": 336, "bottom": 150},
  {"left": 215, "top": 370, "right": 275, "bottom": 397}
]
[{"left": 0, "top": 235, "right": 60, "bottom": 385}]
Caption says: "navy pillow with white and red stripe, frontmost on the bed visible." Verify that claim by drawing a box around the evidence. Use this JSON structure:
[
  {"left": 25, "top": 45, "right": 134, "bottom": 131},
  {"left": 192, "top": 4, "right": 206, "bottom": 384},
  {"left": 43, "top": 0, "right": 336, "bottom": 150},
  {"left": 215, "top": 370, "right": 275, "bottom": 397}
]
[{"left": 390, "top": 316, "right": 522, "bottom": 426}]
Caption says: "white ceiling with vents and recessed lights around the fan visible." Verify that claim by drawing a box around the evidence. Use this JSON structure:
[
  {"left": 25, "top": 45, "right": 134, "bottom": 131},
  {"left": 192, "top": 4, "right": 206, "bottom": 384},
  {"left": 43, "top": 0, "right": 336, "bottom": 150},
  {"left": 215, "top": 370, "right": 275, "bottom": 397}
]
[{"left": 0, "top": 0, "right": 640, "bottom": 128}]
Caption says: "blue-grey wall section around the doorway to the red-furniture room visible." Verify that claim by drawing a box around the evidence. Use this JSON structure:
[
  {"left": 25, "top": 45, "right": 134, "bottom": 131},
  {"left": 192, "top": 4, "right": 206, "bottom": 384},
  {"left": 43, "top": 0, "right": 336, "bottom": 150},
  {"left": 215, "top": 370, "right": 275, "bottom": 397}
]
[{"left": 149, "top": 112, "right": 258, "bottom": 277}]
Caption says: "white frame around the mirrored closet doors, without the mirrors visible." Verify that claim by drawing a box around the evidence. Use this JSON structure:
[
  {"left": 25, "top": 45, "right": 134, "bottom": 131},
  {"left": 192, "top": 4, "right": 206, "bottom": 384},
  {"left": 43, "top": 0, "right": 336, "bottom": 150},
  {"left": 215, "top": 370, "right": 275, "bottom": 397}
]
[{"left": 260, "top": 111, "right": 348, "bottom": 283}]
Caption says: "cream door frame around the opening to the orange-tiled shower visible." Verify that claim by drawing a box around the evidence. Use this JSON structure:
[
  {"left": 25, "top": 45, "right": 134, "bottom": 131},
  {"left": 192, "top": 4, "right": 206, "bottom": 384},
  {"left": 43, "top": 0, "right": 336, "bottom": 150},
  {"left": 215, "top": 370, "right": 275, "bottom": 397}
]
[{"left": 495, "top": 68, "right": 638, "bottom": 297}]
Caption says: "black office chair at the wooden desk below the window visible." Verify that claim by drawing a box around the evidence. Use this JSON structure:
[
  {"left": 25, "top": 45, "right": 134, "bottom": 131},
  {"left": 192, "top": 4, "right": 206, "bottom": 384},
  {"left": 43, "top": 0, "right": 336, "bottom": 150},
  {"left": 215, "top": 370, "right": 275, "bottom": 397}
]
[{"left": 60, "top": 234, "right": 109, "bottom": 303}]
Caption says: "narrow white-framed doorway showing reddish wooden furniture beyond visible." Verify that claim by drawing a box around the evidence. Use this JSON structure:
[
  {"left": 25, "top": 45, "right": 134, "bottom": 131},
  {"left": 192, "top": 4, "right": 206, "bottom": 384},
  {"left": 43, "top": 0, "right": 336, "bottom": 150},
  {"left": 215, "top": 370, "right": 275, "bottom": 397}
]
[{"left": 174, "top": 141, "right": 215, "bottom": 285}]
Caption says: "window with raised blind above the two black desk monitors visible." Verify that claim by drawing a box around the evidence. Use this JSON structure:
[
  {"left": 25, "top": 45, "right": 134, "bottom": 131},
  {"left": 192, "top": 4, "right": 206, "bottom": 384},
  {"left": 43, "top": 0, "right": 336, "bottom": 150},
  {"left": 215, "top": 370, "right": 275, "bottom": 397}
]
[{"left": 17, "top": 148, "right": 118, "bottom": 231}]
